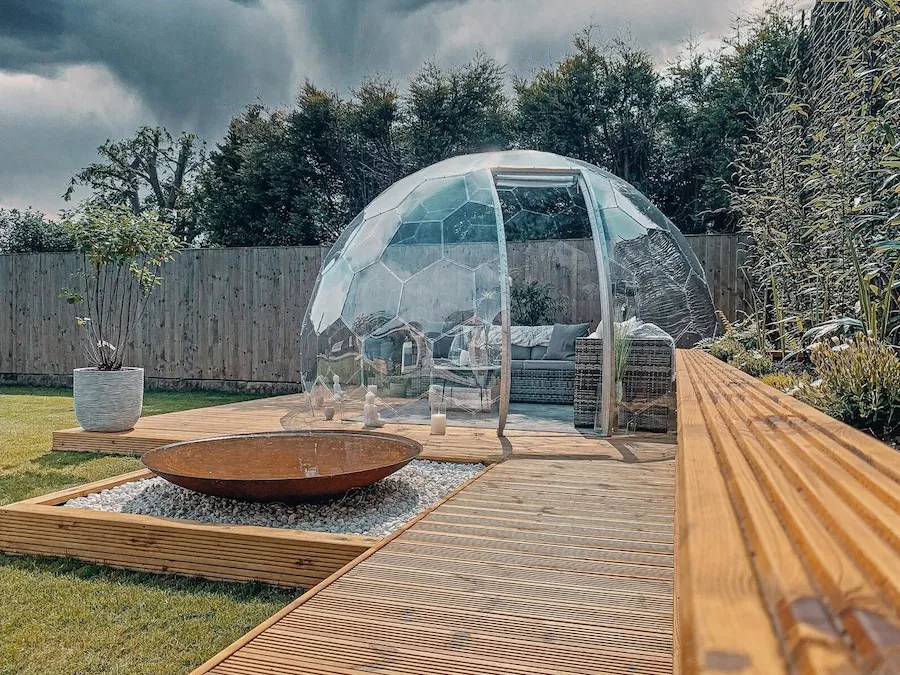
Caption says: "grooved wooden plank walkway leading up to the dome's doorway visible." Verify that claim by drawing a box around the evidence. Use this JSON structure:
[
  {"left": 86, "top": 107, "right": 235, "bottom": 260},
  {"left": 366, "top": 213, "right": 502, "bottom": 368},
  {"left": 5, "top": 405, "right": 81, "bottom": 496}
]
[{"left": 195, "top": 454, "right": 675, "bottom": 675}]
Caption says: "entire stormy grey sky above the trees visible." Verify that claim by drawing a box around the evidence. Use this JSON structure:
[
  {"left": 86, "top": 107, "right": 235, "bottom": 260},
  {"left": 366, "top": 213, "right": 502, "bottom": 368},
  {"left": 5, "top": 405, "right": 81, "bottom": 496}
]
[{"left": 0, "top": 0, "right": 760, "bottom": 214}]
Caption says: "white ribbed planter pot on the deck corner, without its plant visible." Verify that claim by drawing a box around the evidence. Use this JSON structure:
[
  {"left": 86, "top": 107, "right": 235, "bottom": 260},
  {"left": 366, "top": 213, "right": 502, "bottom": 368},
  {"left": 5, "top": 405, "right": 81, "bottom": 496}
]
[{"left": 72, "top": 368, "right": 144, "bottom": 431}]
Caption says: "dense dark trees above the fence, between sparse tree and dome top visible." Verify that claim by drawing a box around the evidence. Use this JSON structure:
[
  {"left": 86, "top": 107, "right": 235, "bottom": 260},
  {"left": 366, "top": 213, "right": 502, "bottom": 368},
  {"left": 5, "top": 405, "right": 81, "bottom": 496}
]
[{"left": 198, "top": 78, "right": 409, "bottom": 246}]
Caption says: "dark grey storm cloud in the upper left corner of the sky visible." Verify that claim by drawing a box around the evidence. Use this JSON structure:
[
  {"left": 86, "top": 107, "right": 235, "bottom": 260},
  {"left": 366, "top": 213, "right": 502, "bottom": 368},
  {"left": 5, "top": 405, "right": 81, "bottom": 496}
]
[{"left": 0, "top": 0, "right": 292, "bottom": 129}]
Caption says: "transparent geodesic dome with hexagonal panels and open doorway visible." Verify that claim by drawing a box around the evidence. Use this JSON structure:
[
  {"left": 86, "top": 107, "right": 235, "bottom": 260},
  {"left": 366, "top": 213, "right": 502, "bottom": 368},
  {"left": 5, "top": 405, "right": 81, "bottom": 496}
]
[{"left": 302, "top": 151, "right": 717, "bottom": 434}]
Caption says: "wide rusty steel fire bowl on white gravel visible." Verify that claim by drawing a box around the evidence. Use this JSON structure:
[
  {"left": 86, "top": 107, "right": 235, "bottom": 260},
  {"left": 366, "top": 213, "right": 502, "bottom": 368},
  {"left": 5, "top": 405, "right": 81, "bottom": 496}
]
[{"left": 141, "top": 431, "right": 422, "bottom": 503}]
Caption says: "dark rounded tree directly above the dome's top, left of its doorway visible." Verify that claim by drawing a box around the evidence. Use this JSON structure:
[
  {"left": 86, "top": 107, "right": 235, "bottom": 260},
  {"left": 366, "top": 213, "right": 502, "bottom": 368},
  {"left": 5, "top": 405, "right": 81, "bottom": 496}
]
[{"left": 404, "top": 52, "right": 512, "bottom": 168}]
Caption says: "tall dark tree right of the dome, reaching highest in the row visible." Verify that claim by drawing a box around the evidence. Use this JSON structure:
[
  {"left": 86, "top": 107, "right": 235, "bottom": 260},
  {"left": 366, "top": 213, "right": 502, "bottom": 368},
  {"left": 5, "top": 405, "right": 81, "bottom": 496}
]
[{"left": 648, "top": 3, "right": 800, "bottom": 232}]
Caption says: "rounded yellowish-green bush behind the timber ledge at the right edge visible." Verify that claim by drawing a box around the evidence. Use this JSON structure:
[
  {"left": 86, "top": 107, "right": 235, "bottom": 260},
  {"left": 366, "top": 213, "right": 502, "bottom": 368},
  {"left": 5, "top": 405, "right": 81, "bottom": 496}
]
[{"left": 798, "top": 334, "right": 900, "bottom": 437}]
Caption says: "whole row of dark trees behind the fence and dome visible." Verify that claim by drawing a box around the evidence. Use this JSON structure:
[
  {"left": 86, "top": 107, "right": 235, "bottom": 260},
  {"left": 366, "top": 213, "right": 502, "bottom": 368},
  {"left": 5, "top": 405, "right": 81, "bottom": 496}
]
[{"left": 49, "top": 6, "right": 799, "bottom": 251}]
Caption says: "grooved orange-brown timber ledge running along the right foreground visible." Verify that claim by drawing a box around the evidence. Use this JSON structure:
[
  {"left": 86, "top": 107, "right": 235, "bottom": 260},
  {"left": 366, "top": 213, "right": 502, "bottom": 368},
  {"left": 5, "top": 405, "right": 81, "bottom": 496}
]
[{"left": 675, "top": 350, "right": 900, "bottom": 675}]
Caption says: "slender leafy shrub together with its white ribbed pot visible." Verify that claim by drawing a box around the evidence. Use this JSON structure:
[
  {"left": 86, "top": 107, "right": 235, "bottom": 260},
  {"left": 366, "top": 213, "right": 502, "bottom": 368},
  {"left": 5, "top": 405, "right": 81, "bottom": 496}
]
[{"left": 62, "top": 203, "right": 180, "bottom": 432}]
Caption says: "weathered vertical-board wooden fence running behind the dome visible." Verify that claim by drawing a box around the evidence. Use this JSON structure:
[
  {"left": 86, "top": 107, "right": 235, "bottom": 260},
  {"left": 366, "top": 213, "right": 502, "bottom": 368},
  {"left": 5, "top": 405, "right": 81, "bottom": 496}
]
[{"left": 0, "top": 235, "right": 747, "bottom": 385}]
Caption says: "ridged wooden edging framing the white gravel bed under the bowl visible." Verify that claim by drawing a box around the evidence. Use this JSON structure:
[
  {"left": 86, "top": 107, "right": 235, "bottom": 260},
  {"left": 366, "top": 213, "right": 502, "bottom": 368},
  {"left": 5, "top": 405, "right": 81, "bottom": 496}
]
[{"left": 0, "top": 471, "right": 378, "bottom": 588}]
